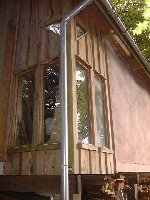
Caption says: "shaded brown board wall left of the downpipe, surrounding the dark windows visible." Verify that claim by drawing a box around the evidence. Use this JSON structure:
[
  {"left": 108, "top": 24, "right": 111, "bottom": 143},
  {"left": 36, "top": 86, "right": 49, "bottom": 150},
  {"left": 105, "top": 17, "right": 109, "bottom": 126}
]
[{"left": 0, "top": 0, "right": 70, "bottom": 175}]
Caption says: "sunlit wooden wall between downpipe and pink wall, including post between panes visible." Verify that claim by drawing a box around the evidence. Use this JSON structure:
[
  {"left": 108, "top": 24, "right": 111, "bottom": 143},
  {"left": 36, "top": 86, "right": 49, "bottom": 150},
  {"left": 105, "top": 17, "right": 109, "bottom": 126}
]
[{"left": 74, "top": 5, "right": 115, "bottom": 174}]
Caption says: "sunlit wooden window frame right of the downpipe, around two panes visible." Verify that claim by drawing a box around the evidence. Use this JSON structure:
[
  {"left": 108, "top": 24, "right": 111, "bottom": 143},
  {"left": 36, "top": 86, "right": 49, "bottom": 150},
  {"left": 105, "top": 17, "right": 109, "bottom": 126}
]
[{"left": 76, "top": 56, "right": 110, "bottom": 149}]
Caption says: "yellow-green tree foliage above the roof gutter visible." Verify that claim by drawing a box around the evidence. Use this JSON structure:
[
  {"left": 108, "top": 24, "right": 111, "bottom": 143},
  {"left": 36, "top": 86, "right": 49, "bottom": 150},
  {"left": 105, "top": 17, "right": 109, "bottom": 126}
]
[{"left": 110, "top": 0, "right": 150, "bottom": 62}]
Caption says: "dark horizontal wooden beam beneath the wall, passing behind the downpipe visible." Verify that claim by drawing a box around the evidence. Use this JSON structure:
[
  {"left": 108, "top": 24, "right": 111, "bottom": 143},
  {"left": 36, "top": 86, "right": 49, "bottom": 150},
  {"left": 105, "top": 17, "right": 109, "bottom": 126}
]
[{"left": 0, "top": 175, "right": 82, "bottom": 194}]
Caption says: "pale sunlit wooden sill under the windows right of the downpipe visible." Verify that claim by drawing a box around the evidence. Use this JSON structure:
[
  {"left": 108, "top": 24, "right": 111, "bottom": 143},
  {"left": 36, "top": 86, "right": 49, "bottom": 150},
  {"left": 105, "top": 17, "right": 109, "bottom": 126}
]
[{"left": 77, "top": 142, "right": 114, "bottom": 154}]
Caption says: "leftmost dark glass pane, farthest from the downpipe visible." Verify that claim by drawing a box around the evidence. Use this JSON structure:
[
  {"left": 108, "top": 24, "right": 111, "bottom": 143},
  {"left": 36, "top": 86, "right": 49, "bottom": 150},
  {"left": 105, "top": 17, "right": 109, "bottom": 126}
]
[{"left": 16, "top": 72, "right": 35, "bottom": 145}]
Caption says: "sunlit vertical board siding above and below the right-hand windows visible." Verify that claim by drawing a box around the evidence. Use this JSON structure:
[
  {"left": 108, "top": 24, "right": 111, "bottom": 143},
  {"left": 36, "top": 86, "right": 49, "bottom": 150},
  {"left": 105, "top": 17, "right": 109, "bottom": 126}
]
[{"left": 76, "top": 8, "right": 114, "bottom": 174}]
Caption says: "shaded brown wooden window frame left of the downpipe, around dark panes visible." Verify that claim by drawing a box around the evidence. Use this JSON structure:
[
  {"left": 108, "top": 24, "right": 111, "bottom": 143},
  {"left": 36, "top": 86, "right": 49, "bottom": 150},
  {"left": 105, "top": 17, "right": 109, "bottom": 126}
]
[{"left": 8, "top": 58, "right": 61, "bottom": 153}]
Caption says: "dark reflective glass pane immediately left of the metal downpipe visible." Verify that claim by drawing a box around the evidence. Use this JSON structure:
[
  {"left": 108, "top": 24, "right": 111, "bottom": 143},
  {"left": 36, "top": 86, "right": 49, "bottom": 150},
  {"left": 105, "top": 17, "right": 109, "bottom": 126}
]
[{"left": 44, "top": 64, "right": 60, "bottom": 143}]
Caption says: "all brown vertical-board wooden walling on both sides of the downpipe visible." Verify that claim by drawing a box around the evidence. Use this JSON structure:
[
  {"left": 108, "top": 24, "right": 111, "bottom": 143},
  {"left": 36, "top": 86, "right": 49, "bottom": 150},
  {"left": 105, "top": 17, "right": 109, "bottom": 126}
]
[{"left": 0, "top": 0, "right": 114, "bottom": 175}]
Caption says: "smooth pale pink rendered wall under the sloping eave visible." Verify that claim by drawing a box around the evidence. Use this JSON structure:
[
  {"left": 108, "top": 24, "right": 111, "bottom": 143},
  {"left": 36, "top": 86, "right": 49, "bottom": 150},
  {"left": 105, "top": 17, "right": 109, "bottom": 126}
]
[{"left": 107, "top": 42, "right": 150, "bottom": 172}]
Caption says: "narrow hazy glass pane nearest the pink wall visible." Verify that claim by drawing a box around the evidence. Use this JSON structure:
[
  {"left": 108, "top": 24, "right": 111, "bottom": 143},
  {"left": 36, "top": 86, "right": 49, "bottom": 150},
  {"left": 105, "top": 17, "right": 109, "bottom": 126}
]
[{"left": 95, "top": 77, "right": 106, "bottom": 147}]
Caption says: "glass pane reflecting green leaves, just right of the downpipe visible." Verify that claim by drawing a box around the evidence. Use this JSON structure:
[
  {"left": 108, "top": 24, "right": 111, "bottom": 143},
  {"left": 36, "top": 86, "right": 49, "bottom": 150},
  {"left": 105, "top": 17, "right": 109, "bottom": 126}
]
[{"left": 76, "top": 65, "right": 89, "bottom": 143}]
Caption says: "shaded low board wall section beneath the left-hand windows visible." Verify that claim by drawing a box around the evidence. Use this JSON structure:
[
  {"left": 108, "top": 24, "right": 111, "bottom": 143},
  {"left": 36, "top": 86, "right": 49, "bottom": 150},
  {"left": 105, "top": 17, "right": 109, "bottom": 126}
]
[{"left": 4, "top": 147, "right": 61, "bottom": 175}]
